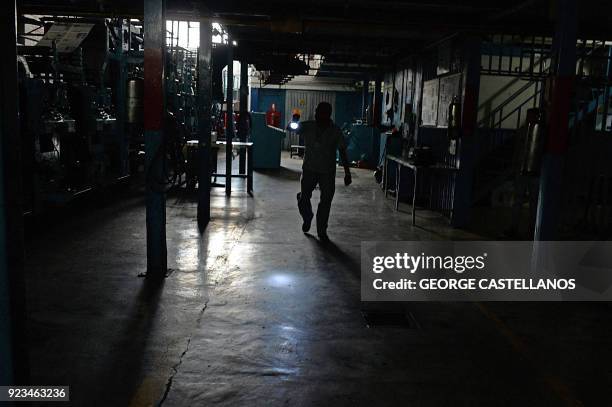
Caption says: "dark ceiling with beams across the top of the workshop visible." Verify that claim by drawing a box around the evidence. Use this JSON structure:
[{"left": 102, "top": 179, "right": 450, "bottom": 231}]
[{"left": 18, "top": 0, "right": 612, "bottom": 81}]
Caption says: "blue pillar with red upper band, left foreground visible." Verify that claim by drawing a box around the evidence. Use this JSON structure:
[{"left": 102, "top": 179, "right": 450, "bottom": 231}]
[{"left": 144, "top": 0, "right": 167, "bottom": 278}]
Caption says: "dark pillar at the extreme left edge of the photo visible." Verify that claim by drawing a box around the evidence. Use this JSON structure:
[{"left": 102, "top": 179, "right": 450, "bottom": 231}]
[{"left": 0, "top": 0, "right": 29, "bottom": 385}]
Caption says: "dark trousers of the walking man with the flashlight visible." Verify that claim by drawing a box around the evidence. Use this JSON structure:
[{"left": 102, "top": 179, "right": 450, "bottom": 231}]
[{"left": 298, "top": 170, "right": 336, "bottom": 234}]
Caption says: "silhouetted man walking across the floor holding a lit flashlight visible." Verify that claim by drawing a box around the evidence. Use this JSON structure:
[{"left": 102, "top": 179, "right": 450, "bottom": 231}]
[{"left": 297, "top": 102, "right": 352, "bottom": 243}]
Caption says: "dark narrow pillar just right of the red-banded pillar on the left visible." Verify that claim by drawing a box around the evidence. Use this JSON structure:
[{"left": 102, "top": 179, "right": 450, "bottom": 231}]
[{"left": 198, "top": 18, "right": 212, "bottom": 230}]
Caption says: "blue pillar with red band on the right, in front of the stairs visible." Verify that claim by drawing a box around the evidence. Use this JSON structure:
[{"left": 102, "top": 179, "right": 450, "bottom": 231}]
[{"left": 534, "top": 0, "right": 577, "bottom": 240}]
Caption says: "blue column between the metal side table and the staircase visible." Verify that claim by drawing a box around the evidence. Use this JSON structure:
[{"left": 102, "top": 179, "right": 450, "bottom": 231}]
[{"left": 452, "top": 37, "right": 480, "bottom": 227}]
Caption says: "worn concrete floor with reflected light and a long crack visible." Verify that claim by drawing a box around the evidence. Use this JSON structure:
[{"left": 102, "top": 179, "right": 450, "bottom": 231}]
[{"left": 26, "top": 157, "right": 612, "bottom": 406}]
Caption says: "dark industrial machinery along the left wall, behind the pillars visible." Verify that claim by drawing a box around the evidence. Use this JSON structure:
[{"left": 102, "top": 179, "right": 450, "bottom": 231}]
[{"left": 18, "top": 16, "right": 208, "bottom": 213}]
